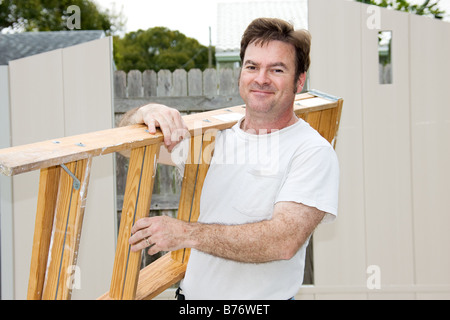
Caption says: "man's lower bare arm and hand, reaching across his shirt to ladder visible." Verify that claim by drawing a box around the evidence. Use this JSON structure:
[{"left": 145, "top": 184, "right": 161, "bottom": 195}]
[{"left": 130, "top": 202, "right": 325, "bottom": 263}]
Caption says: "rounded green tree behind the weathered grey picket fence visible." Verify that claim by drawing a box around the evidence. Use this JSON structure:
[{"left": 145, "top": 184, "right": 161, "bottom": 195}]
[{"left": 114, "top": 27, "right": 214, "bottom": 72}]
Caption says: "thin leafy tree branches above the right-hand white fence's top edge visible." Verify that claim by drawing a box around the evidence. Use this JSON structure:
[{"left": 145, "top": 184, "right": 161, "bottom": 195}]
[{"left": 356, "top": 0, "right": 445, "bottom": 19}]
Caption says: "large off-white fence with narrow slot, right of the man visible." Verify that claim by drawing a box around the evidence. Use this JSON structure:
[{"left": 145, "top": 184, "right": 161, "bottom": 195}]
[{"left": 308, "top": 0, "right": 450, "bottom": 299}]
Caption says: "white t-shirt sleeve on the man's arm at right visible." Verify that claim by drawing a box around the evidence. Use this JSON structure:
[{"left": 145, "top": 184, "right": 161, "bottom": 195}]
[{"left": 276, "top": 146, "right": 339, "bottom": 222}]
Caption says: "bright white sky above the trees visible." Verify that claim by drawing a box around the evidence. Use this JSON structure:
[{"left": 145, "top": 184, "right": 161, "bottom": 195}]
[{"left": 94, "top": 0, "right": 450, "bottom": 46}]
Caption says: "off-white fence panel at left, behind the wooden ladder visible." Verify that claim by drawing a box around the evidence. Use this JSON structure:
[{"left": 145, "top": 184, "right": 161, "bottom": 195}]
[{"left": 2, "top": 38, "right": 116, "bottom": 299}]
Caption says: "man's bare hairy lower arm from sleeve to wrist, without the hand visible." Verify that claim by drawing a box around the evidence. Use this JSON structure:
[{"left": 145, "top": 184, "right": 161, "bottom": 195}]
[{"left": 185, "top": 203, "right": 324, "bottom": 263}]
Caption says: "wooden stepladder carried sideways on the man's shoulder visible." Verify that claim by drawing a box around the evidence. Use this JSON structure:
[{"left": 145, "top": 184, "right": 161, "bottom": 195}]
[{"left": 0, "top": 91, "right": 343, "bottom": 300}]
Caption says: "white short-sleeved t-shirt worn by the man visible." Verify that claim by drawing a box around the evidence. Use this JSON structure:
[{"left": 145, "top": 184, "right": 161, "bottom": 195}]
[{"left": 181, "top": 119, "right": 339, "bottom": 299}]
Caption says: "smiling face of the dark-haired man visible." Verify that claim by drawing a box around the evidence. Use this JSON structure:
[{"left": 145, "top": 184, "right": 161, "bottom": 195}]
[{"left": 239, "top": 41, "right": 301, "bottom": 118}]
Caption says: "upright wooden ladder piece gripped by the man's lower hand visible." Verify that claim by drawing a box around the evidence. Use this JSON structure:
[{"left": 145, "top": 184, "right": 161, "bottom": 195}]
[{"left": 109, "top": 145, "right": 159, "bottom": 300}]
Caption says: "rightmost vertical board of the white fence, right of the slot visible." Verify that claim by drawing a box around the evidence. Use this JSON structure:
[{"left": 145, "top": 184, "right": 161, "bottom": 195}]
[{"left": 410, "top": 16, "right": 450, "bottom": 285}]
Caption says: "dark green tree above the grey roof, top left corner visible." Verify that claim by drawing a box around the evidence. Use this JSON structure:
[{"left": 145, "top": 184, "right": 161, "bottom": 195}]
[{"left": 0, "top": 0, "right": 124, "bottom": 34}]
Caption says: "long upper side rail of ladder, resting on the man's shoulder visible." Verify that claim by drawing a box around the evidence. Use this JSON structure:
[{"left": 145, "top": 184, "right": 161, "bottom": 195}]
[{"left": 0, "top": 94, "right": 338, "bottom": 176}]
